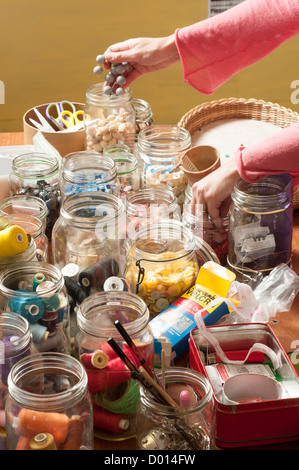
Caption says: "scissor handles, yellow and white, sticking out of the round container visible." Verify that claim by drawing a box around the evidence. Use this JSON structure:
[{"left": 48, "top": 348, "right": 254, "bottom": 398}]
[{"left": 46, "top": 100, "right": 83, "bottom": 130}]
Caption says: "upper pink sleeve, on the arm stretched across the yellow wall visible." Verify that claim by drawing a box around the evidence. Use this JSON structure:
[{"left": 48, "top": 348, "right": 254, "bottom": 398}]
[{"left": 175, "top": 0, "right": 299, "bottom": 94}]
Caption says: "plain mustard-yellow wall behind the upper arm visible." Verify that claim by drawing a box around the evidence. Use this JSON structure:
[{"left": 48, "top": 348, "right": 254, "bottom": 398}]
[{"left": 0, "top": 0, "right": 299, "bottom": 132}]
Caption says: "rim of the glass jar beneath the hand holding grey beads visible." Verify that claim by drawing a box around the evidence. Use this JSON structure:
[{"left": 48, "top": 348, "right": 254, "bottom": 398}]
[{"left": 86, "top": 83, "right": 132, "bottom": 108}]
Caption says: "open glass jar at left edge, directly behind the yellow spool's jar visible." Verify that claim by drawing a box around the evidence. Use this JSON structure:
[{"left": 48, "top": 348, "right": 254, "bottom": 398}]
[{"left": 0, "top": 194, "right": 49, "bottom": 232}]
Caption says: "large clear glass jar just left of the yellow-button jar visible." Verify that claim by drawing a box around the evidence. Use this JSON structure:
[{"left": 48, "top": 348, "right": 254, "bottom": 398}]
[{"left": 52, "top": 192, "right": 127, "bottom": 295}]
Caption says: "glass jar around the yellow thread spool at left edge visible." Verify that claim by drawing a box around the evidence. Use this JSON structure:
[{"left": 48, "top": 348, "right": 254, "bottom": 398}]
[{"left": 3, "top": 214, "right": 49, "bottom": 262}]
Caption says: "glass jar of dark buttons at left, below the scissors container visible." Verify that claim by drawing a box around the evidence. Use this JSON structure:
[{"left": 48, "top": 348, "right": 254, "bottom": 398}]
[{"left": 10, "top": 152, "right": 60, "bottom": 240}]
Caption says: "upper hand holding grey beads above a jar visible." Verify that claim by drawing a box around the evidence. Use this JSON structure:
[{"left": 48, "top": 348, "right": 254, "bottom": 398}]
[{"left": 104, "top": 34, "right": 180, "bottom": 88}]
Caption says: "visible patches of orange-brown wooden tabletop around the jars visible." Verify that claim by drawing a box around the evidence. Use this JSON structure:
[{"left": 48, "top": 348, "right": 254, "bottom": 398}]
[{"left": 0, "top": 132, "right": 299, "bottom": 451}]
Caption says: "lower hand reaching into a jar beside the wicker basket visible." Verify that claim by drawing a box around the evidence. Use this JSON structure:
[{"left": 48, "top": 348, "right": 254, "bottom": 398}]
[{"left": 190, "top": 159, "right": 240, "bottom": 219}]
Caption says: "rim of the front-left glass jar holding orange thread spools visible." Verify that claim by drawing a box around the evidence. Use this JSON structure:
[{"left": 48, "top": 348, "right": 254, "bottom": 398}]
[{"left": 7, "top": 352, "right": 87, "bottom": 410}]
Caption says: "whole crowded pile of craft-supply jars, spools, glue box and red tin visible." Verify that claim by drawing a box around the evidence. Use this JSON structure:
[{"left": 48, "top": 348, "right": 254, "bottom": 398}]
[{"left": 0, "top": 50, "right": 299, "bottom": 451}]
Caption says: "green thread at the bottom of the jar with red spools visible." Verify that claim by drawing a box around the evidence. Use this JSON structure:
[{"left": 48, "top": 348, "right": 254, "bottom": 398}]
[{"left": 95, "top": 379, "right": 140, "bottom": 415}]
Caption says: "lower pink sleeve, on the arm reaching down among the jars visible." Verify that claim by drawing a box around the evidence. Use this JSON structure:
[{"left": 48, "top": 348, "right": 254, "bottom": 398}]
[{"left": 236, "top": 123, "right": 299, "bottom": 182}]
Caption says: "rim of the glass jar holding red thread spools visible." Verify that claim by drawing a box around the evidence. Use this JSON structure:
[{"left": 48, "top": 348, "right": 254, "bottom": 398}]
[{"left": 77, "top": 291, "right": 149, "bottom": 340}]
